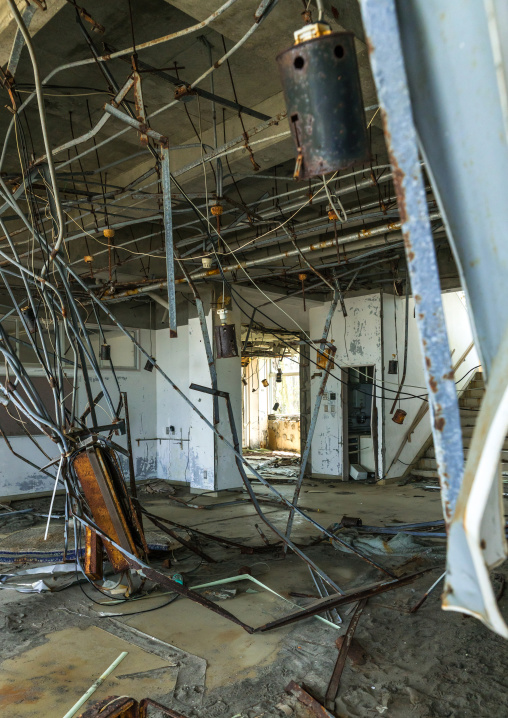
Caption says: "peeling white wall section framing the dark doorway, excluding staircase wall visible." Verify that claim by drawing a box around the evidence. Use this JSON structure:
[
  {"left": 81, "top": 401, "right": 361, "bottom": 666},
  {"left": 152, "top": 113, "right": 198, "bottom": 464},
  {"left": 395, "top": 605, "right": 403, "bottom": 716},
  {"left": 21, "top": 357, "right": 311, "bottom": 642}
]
[{"left": 309, "top": 294, "right": 382, "bottom": 478}]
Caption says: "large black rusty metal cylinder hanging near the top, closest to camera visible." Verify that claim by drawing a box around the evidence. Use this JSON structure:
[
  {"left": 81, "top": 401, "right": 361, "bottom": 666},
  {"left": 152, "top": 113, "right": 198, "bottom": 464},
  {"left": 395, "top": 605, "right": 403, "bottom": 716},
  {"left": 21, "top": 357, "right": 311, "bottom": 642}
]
[{"left": 277, "top": 23, "right": 369, "bottom": 179}]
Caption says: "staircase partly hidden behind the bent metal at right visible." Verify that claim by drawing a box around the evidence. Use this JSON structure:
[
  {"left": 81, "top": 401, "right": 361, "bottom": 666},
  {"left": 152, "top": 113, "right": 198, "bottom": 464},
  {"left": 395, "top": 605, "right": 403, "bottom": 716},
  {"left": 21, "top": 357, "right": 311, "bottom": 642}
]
[{"left": 411, "top": 370, "right": 508, "bottom": 479}]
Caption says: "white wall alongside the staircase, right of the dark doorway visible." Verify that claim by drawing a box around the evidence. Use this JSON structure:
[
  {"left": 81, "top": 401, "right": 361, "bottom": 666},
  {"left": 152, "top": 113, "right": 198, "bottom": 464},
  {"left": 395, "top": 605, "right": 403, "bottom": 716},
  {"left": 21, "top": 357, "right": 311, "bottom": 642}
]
[{"left": 383, "top": 292, "right": 480, "bottom": 478}]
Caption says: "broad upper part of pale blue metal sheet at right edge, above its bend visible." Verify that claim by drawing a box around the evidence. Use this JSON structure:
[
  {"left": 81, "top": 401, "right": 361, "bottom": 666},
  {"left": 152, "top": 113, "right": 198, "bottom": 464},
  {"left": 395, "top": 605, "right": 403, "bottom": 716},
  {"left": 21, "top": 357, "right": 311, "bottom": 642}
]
[{"left": 397, "top": 0, "right": 508, "bottom": 376}]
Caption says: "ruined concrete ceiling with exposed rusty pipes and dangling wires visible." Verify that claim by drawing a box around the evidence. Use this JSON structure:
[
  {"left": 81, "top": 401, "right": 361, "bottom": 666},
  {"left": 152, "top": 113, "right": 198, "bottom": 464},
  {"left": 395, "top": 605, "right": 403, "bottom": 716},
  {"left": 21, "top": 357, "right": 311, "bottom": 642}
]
[{"left": 0, "top": 0, "right": 459, "bottom": 324}]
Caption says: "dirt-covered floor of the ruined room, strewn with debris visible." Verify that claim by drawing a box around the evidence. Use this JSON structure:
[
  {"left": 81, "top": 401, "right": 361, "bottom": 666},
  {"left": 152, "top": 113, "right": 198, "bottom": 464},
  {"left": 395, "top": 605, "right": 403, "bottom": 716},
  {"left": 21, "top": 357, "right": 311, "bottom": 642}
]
[{"left": 0, "top": 476, "right": 508, "bottom": 718}]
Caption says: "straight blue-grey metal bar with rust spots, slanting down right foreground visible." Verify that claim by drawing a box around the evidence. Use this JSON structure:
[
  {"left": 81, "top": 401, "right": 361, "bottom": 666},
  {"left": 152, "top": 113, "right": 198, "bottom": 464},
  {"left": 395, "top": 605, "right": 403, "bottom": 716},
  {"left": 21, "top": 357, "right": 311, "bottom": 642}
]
[{"left": 360, "top": 0, "right": 464, "bottom": 523}]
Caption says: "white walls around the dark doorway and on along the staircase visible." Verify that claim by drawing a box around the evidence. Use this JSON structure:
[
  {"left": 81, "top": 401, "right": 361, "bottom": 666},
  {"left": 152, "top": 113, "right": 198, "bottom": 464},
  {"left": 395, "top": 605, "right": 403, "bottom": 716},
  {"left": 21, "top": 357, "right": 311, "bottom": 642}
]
[{"left": 310, "top": 292, "right": 479, "bottom": 478}]
